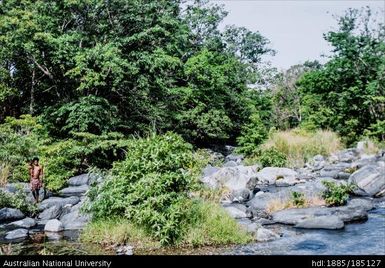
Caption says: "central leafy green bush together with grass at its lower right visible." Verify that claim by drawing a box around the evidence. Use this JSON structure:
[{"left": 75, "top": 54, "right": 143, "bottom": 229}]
[{"left": 86, "top": 133, "right": 250, "bottom": 245}]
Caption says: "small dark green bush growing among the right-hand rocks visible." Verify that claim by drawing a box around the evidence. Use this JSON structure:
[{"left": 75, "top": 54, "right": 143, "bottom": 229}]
[{"left": 322, "top": 181, "right": 356, "bottom": 206}]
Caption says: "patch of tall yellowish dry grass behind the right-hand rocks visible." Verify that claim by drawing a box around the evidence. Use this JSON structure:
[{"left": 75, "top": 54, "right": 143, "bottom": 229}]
[{"left": 261, "top": 129, "right": 343, "bottom": 167}]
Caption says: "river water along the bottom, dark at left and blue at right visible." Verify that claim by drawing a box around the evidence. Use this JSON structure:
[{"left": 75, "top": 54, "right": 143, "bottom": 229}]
[{"left": 0, "top": 206, "right": 385, "bottom": 255}]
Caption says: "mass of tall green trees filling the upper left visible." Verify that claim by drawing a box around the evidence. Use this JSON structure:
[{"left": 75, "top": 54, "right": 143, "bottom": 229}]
[{"left": 0, "top": 0, "right": 274, "bottom": 145}]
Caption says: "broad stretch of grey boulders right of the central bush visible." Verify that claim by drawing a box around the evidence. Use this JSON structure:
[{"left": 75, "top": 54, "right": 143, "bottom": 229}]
[{"left": 201, "top": 142, "right": 385, "bottom": 242}]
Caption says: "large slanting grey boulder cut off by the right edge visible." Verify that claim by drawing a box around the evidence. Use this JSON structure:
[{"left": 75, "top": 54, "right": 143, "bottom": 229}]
[{"left": 349, "top": 165, "right": 385, "bottom": 196}]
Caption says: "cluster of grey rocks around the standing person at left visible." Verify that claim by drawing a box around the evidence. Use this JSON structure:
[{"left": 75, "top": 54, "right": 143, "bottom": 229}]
[{"left": 0, "top": 174, "right": 97, "bottom": 242}]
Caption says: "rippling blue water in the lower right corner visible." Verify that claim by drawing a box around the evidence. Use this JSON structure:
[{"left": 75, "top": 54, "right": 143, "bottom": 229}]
[{"left": 225, "top": 207, "right": 385, "bottom": 255}]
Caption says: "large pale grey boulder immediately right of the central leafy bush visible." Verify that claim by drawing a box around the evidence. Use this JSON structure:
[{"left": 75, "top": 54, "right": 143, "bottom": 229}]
[{"left": 201, "top": 165, "right": 258, "bottom": 191}]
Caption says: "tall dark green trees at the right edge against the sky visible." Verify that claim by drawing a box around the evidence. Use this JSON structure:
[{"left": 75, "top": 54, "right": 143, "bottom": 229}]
[{"left": 299, "top": 9, "right": 385, "bottom": 143}]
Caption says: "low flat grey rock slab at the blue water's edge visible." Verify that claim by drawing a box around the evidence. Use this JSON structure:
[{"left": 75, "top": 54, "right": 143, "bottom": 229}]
[{"left": 294, "top": 216, "right": 344, "bottom": 230}]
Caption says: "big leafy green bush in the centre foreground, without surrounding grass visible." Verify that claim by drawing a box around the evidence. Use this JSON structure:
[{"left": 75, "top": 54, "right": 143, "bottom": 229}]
[{"left": 85, "top": 133, "right": 194, "bottom": 244}]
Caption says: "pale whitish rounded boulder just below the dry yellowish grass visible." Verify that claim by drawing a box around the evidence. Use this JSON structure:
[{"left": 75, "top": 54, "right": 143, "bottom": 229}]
[{"left": 257, "top": 167, "right": 298, "bottom": 184}]
